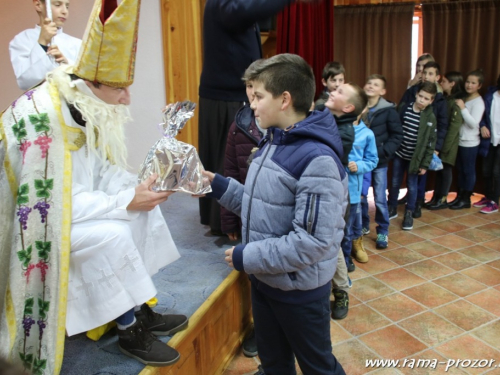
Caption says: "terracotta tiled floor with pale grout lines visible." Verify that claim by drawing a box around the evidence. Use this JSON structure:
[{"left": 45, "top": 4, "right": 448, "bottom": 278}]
[{"left": 224, "top": 194, "right": 500, "bottom": 375}]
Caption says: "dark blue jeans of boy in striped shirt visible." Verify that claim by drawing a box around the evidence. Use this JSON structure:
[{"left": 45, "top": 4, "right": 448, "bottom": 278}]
[{"left": 388, "top": 155, "right": 418, "bottom": 211}]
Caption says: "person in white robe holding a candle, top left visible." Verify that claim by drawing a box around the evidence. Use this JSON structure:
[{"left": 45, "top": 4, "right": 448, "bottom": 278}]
[{"left": 9, "top": 0, "right": 82, "bottom": 90}]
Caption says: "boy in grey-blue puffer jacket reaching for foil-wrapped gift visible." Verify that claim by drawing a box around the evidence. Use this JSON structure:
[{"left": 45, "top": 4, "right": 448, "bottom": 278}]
[{"left": 201, "top": 54, "right": 347, "bottom": 375}]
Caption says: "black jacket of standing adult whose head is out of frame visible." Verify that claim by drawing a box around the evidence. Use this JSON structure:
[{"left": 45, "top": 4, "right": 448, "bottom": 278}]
[{"left": 199, "top": 0, "right": 292, "bottom": 102}]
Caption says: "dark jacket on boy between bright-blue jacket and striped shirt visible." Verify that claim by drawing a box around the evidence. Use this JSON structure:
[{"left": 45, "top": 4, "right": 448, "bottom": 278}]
[{"left": 363, "top": 97, "right": 403, "bottom": 168}]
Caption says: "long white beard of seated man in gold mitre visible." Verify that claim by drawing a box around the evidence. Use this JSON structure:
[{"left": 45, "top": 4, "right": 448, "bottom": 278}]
[{"left": 47, "top": 66, "right": 132, "bottom": 169}]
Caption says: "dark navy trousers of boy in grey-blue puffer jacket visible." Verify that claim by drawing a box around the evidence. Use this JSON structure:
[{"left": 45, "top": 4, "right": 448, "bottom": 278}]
[{"left": 252, "top": 284, "right": 345, "bottom": 375}]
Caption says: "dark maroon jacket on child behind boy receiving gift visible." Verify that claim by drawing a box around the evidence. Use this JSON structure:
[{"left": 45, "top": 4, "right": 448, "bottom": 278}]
[{"left": 221, "top": 105, "right": 262, "bottom": 233}]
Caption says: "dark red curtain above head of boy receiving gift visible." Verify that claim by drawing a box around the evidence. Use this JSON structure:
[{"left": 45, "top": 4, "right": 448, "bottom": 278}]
[{"left": 276, "top": 0, "right": 333, "bottom": 100}]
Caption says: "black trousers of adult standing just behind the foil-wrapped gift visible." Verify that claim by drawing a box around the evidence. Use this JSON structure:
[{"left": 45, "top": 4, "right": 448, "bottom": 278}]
[{"left": 198, "top": 98, "right": 242, "bottom": 231}]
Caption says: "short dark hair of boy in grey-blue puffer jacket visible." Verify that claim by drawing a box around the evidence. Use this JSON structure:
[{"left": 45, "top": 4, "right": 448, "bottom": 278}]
[{"left": 244, "top": 53, "right": 316, "bottom": 114}]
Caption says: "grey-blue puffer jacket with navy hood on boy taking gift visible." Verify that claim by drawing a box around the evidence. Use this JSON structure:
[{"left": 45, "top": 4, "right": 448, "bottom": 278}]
[{"left": 211, "top": 111, "right": 348, "bottom": 304}]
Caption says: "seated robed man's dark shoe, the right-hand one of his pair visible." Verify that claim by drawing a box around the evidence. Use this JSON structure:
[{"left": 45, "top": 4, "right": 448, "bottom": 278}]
[{"left": 135, "top": 303, "right": 189, "bottom": 336}]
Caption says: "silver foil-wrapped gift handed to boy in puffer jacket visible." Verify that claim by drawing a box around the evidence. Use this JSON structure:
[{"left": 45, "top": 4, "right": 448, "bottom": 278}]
[{"left": 138, "top": 101, "right": 212, "bottom": 194}]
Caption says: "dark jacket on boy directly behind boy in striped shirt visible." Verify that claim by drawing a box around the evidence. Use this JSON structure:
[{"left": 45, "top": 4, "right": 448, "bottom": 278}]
[{"left": 398, "top": 83, "right": 448, "bottom": 151}]
